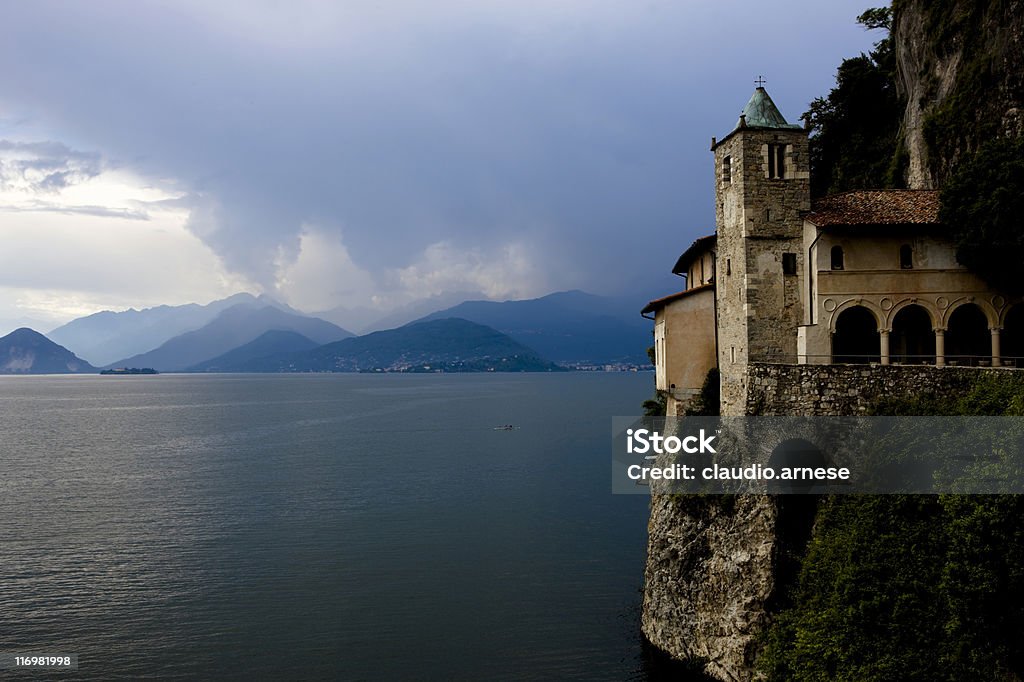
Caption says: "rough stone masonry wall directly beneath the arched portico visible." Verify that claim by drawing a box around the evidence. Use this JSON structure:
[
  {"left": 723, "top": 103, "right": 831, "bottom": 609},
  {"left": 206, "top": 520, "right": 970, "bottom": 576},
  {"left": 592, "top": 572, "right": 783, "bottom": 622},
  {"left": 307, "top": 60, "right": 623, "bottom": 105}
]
[{"left": 746, "top": 364, "right": 1024, "bottom": 416}]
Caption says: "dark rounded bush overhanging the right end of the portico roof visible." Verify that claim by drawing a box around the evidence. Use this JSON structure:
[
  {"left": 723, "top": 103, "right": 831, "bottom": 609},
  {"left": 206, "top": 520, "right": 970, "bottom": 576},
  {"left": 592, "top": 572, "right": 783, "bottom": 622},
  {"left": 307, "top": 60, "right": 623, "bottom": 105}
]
[{"left": 939, "top": 138, "right": 1024, "bottom": 295}]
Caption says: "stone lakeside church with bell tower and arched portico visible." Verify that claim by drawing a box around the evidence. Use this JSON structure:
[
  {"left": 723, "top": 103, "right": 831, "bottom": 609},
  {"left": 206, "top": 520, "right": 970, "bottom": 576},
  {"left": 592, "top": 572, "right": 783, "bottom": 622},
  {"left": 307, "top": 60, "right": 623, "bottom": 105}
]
[{"left": 644, "top": 87, "right": 1024, "bottom": 415}]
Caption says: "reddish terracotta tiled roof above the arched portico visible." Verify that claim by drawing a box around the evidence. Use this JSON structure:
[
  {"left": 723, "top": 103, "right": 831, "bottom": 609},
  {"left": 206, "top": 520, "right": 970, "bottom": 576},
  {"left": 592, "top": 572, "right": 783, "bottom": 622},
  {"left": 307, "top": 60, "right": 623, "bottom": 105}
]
[{"left": 807, "top": 189, "right": 939, "bottom": 227}]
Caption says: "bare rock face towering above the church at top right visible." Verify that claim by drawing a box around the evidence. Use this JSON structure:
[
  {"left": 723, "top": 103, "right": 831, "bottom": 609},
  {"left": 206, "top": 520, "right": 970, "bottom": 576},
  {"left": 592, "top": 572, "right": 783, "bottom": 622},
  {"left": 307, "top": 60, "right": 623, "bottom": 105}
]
[{"left": 893, "top": 0, "right": 1024, "bottom": 189}]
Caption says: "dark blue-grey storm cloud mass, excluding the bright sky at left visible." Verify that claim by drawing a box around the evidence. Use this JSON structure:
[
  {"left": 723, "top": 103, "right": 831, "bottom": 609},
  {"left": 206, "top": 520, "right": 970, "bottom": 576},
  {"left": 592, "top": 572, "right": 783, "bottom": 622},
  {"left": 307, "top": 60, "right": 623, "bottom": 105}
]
[{"left": 0, "top": 0, "right": 872, "bottom": 303}]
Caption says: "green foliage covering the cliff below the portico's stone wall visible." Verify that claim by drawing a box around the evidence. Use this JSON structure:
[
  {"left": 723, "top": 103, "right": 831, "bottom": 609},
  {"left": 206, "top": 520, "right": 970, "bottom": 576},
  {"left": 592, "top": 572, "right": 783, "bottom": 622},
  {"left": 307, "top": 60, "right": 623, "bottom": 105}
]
[{"left": 758, "top": 375, "right": 1024, "bottom": 682}]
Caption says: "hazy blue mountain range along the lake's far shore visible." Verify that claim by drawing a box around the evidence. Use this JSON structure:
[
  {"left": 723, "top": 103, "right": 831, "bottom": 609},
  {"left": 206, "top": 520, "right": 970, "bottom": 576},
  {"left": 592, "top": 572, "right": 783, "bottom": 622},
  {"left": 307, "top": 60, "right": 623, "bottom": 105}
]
[{"left": 12, "top": 291, "right": 650, "bottom": 372}]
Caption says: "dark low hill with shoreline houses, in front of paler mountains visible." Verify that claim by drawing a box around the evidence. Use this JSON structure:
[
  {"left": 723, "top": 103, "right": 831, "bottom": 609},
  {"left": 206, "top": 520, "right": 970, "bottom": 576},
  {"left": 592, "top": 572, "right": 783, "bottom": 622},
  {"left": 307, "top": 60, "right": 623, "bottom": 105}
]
[{"left": 214, "top": 318, "right": 561, "bottom": 372}]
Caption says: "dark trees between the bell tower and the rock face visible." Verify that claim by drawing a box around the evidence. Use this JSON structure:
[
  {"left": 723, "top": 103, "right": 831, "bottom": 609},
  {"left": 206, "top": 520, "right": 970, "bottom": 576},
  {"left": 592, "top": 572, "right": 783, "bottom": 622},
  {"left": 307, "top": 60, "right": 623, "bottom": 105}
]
[{"left": 804, "top": 7, "right": 906, "bottom": 197}]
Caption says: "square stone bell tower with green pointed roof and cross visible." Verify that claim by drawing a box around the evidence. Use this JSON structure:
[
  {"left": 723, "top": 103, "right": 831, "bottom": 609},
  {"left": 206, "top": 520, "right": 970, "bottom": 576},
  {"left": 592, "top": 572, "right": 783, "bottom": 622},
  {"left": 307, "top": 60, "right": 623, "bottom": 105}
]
[{"left": 711, "top": 84, "right": 811, "bottom": 415}]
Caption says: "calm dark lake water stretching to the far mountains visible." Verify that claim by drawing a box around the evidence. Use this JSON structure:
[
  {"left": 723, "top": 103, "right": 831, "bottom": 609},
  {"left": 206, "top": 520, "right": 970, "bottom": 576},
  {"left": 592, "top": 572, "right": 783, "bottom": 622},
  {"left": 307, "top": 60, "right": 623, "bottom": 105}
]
[{"left": 0, "top": 374, "right": 653, "bottom": 680}]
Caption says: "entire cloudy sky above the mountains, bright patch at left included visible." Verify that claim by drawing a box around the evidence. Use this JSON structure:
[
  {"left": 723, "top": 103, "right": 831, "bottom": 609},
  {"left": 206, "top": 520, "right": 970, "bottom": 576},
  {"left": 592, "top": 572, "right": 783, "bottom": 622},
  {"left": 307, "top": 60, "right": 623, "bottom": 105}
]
[{"left": 0, "top": 0, "right": 879, "bottom": 331}]
